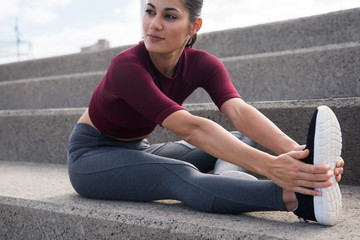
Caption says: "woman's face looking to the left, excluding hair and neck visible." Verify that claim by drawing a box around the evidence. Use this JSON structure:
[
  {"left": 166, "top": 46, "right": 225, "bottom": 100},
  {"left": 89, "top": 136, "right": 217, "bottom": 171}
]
[{"left": 143, "top": 0, "right": 193, "bottom": 53}]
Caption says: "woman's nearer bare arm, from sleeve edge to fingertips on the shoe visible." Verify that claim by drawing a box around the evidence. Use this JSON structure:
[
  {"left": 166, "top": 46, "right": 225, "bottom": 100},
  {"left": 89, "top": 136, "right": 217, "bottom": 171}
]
[{"left": 162, "top": 110, "right": 331, "bottom": 195}]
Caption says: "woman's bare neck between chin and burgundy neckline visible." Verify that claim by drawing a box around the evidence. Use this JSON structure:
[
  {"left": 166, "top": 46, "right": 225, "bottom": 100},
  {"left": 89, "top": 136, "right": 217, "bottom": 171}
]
[{"left": 149, "top": 49, "right": 184, "bottom": 78}]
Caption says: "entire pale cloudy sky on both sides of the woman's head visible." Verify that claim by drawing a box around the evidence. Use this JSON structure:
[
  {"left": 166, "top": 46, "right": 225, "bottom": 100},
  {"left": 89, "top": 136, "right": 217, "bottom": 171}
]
[{"left": 0, "top": 0, "right": 360, "bottom": 64}]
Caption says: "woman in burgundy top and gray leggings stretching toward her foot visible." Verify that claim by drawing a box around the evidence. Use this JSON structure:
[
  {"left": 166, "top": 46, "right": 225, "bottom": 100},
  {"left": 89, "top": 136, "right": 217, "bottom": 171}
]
[{"left": 68, "top": 0, "right": 344, "bottom": 224}]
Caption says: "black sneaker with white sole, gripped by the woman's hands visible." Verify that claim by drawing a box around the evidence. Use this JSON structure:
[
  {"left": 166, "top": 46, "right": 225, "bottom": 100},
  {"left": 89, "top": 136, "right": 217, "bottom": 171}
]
[{"left": 294, "top": 106, "right": 342, "bottom": 225}]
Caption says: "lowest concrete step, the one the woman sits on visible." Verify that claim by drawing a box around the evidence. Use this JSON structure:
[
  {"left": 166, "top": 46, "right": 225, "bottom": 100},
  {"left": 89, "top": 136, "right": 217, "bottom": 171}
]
[{"left": 0, "top": 161, "right": 360, "bottom": 240}]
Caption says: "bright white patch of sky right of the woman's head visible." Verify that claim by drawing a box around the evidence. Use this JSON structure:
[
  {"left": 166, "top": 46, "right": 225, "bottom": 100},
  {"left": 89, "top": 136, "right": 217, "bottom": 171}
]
[{"left": 201, "top": 0, "right": 360, "bottom": 32}]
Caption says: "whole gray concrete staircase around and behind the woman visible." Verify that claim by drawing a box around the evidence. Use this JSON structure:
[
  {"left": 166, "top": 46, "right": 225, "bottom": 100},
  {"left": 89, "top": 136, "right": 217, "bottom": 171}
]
[{"left": 0, "top": 8, "right": 360, "bottom": 239}]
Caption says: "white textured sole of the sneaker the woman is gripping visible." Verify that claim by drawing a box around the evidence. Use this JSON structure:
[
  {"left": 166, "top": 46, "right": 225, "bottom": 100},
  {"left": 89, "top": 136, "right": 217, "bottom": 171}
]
[{"left": 314, "top": 106, "right": 342, "bottom": 225}]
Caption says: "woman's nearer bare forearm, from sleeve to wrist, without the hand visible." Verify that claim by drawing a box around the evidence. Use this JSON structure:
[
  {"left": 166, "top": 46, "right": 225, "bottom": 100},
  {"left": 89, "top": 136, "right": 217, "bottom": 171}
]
[{"left": 162, "top": 110, "right": 274, "bottom": 173}]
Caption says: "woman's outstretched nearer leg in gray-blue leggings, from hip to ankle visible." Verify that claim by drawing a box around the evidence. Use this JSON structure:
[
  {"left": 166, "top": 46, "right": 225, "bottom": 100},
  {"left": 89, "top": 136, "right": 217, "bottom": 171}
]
[{"left": 69, "top": 146, "right": 285, "bottom": 213}]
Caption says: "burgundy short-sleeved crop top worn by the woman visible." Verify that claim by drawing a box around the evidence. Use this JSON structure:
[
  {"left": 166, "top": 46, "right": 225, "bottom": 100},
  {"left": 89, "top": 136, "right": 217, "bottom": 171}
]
[{"left": 89, "top": 43, "right": 240, "bottom": 138}]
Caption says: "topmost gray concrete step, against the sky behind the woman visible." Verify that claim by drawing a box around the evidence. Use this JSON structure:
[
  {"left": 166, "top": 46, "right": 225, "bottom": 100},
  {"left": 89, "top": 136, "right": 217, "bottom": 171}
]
[{"left": 0, "top": 8, "right": 360, "bottom": 81}]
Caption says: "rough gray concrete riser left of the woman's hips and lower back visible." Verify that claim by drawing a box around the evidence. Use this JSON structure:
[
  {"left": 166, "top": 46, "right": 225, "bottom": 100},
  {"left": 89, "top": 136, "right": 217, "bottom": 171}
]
[{"left": 0, "top": 108, "right": 80, "bottom": 163}]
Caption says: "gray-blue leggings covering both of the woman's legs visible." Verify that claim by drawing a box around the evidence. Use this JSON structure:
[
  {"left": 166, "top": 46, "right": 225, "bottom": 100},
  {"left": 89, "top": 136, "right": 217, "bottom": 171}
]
[{"left": 68, "top": 124, "right": 286, "bottom": 214}]
